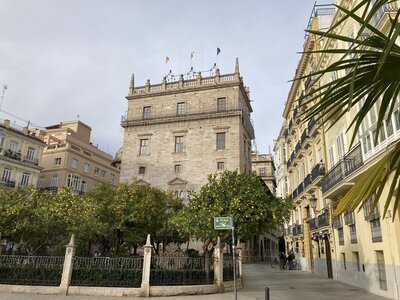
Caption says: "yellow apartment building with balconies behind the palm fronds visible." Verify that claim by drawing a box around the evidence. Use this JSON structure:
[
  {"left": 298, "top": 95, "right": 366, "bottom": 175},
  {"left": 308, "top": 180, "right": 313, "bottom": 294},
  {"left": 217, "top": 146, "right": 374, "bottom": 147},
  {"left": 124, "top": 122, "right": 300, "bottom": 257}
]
[{"left": 274, "top": 1, "right": 400, "bottom": 299}]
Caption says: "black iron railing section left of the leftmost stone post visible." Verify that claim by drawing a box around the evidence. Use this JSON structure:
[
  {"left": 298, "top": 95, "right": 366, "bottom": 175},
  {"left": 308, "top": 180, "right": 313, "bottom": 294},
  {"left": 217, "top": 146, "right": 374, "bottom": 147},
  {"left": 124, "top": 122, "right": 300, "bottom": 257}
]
[{"left": 0, "top": 255, "right": 64, "bottom": 286}]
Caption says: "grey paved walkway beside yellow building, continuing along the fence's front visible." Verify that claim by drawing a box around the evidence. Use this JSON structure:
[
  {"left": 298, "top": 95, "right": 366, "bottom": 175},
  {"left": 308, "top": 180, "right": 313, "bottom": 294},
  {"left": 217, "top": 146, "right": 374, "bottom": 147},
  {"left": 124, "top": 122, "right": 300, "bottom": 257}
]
[{"left": 0, "top": 263, "right": 387, "bottom": 300}]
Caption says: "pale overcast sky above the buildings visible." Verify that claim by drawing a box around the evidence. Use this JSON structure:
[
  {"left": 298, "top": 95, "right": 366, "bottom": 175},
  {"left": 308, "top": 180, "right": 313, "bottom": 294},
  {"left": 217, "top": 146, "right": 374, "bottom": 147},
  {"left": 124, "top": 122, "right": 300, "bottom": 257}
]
[{"left": 0, "top": 0, "right": 330, "bottom": 154}]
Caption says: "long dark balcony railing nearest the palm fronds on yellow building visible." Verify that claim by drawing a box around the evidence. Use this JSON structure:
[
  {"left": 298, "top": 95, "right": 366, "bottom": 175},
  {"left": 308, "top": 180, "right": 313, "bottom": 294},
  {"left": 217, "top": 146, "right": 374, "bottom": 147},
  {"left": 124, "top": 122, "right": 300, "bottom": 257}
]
[{"left": 322, "top": 144, "right": 363, "bottom": 193}]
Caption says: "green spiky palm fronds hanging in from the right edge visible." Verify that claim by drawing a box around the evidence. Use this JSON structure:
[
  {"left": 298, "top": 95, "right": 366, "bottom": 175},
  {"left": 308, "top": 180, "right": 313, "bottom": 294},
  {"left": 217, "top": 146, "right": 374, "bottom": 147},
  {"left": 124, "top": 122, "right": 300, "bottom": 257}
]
[{"left": 295, "top": 0, "right": 400, "bottom": 218}]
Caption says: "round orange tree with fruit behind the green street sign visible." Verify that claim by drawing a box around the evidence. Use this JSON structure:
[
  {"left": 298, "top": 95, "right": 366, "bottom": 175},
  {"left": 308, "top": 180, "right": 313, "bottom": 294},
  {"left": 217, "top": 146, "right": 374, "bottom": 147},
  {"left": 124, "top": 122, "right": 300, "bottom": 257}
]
[{"left": 173, "top": 171, "right": 292, "bottom": 251}]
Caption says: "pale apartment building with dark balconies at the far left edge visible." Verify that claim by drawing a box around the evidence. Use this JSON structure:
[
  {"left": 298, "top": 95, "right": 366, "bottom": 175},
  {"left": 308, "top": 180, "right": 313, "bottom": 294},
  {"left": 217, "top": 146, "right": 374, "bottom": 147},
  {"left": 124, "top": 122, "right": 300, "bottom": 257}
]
[{"left": 0, "top": 120, "right": 46, "bottom": 189}]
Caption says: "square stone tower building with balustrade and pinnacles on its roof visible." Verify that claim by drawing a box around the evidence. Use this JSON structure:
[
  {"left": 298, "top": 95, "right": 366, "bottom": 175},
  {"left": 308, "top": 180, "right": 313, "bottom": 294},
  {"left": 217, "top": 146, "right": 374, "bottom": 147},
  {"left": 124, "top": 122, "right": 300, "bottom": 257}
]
[{"left": 121, "top": 59, "right": 254, "bottom": 198}]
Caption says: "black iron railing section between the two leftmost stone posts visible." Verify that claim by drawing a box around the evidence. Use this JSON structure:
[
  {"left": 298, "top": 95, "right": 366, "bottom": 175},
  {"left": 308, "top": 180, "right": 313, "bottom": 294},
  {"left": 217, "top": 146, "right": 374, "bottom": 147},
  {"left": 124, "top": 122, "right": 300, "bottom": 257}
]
[{"left": 71, "top": 257, "right": 143, "bottom": 287}]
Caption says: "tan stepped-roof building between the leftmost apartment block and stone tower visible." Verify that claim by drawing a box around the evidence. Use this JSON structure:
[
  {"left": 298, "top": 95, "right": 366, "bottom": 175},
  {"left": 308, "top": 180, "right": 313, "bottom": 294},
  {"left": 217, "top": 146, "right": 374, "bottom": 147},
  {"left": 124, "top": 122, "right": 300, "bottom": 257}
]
[{"left": 38, "top": 121, "right": 119, "bottom": 193}]
